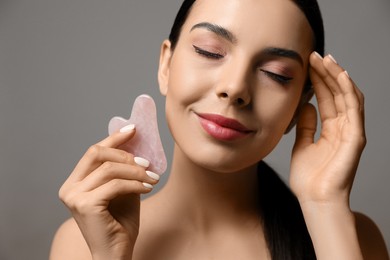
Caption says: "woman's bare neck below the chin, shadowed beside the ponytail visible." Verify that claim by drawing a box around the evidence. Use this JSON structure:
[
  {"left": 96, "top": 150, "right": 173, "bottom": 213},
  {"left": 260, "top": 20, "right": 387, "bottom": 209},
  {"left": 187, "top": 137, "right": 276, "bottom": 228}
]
[{"left": 155, "top": 144, "right": 260, "bottom": 231}]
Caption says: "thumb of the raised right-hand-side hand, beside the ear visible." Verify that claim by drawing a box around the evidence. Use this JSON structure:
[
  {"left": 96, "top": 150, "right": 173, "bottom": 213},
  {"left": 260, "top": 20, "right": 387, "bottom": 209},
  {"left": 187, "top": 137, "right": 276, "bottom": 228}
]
[{"left": 294, "top": 103, "right": 317, "bottom": 150}]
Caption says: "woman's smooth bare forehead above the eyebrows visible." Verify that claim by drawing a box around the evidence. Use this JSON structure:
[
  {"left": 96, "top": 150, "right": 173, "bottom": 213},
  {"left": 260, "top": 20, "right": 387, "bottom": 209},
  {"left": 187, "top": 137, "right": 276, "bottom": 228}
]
[{"left": 182, "top": 0, "right": 312, "bottom": 54}]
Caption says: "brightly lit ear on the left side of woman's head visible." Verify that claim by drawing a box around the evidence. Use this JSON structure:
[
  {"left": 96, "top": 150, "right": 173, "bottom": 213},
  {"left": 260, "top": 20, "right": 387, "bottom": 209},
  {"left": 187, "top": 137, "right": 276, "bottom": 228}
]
[{"left": 157, "top": 40, "right": 172, "bottom": 96}]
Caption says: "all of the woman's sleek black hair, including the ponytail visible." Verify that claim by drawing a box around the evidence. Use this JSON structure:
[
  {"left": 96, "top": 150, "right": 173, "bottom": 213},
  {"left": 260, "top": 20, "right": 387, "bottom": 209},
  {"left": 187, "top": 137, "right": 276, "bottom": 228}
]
[{"left": 169, "top": 0, "right": 325, "bottom": 260}]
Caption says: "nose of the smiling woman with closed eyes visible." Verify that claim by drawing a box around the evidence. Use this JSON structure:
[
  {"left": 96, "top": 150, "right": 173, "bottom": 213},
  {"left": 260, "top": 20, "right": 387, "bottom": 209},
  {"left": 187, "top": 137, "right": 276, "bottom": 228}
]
[{"left": 215, "top": 59, "right": 251, "bottom": 107}]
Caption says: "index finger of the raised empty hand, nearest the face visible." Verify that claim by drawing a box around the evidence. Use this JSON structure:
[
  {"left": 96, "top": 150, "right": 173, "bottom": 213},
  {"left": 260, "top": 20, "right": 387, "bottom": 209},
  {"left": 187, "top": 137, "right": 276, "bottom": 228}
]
[{"left": 310, "top": 66, "right": 337, "bottom": 122}]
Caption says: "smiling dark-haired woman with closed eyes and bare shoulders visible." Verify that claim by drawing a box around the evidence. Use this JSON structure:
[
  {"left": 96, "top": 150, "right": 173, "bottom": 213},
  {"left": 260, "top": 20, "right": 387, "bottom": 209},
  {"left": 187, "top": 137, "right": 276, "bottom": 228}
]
[{"left": 51, "top": 0, "right": 388, "bottom": 260}]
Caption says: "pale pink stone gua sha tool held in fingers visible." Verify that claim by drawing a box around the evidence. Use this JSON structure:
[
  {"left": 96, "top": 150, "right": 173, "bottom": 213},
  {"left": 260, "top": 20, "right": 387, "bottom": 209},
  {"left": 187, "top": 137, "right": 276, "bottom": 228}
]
[{"left": 108, "top": 95, "right": 167, "bottom": 175}]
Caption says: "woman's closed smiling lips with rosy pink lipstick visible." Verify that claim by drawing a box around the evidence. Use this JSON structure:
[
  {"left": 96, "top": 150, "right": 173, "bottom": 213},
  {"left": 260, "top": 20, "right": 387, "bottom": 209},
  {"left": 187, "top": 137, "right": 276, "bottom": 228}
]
[{"left": 196, "top": 113, "right": 253, "bottom": 141}]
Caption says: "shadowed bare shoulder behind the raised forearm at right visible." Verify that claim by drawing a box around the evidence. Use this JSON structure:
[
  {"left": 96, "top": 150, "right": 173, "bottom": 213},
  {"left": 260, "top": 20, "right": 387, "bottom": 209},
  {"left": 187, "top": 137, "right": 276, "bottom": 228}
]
[{"left": 354, "top": 212, "right": 389, "bottom": 260}]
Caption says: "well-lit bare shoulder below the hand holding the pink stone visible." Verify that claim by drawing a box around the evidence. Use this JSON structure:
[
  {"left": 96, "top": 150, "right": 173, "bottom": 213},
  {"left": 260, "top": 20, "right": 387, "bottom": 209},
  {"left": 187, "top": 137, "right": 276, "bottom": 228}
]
[{"left": 50, "top": 218, "right": 92, "bottom": 260}]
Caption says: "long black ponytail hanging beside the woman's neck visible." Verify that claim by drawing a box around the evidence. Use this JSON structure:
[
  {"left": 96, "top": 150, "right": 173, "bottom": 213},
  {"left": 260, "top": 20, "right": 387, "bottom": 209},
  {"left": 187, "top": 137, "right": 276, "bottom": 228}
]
[{"left": 257, "top": 161, "right": 316, "bottom": 260}]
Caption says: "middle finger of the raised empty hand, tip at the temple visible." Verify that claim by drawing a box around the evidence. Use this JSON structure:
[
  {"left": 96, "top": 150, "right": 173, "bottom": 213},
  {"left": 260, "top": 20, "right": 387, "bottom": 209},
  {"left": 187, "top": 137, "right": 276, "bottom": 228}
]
[{"left": 310, "top": 54, "right": 345, "bottom": 114}]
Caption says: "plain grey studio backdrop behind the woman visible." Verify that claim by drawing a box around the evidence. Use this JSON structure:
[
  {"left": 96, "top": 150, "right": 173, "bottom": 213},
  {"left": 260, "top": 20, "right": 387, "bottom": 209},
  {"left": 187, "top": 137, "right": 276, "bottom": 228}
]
[{"left": 0, "top": 0, "right": 390, "bottom": 260}]
